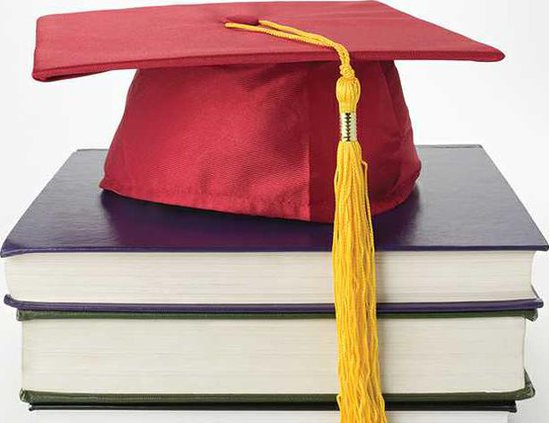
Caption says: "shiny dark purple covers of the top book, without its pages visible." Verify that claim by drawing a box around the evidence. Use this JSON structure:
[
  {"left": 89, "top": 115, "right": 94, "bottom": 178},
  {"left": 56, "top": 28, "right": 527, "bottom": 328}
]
[{"left": 1, "top": 145, "right": 548, "bottom": 313}]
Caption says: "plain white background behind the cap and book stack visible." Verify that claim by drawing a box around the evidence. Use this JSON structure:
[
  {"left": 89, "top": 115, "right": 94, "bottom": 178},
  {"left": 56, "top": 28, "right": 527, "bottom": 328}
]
[{"left": 0, "top": 0, "right": 549, "bottom": 423}]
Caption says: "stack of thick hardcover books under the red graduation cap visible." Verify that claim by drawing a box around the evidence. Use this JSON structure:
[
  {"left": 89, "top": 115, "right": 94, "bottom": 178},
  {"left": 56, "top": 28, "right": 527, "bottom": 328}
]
[{"left": 2, "top": 145, "right": 548, "bottom": 423}]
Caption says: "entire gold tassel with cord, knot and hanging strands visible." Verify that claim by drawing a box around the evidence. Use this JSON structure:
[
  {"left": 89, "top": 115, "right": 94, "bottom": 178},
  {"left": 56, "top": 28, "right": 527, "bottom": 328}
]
[{"left": 225, "top": 20, "right": 387, "bottom": 423}]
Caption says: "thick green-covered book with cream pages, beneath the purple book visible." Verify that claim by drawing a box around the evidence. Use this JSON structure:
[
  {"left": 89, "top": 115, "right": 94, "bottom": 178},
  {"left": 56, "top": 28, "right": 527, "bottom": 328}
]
[{"left": 18, "top": 311, "right": 536, "bottom": 406}]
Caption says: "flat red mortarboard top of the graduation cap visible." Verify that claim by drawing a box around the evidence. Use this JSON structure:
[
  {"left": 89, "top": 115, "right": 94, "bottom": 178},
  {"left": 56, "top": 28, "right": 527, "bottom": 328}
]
[{"left": 33, "top": 1, "right": 503, "bottom": 80}]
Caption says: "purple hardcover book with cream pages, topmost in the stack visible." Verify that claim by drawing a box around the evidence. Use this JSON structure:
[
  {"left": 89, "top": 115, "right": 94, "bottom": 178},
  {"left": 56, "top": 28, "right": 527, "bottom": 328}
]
[{"left": 1, "top": 145, "right": 547, "bottom": 313}]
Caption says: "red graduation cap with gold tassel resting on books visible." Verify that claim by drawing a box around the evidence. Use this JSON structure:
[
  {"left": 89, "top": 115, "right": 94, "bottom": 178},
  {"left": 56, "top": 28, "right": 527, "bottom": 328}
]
[{"left": 33, "top": 1, "right": 503, "bottom": 423}]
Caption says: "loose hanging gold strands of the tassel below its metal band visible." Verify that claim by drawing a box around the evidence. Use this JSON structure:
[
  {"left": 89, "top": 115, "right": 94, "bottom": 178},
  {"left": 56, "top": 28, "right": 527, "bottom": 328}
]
[{"left": 332, "top": 140, "right": 387, "bottom": 423}]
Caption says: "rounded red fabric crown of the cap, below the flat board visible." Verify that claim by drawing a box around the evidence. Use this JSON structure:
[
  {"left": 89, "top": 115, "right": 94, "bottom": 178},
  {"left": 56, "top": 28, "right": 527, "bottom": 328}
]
[{"left": 101, "top": 62, "right": 420, "bottom": 222}]
